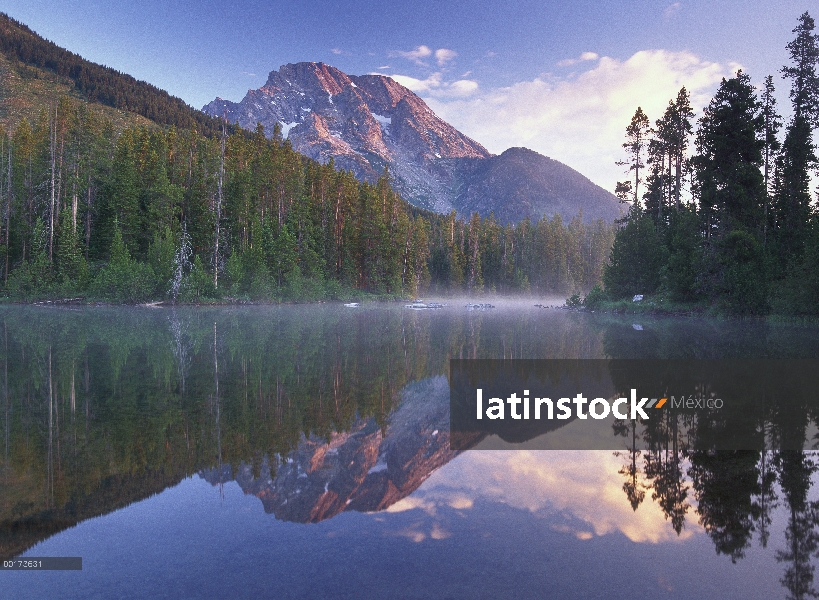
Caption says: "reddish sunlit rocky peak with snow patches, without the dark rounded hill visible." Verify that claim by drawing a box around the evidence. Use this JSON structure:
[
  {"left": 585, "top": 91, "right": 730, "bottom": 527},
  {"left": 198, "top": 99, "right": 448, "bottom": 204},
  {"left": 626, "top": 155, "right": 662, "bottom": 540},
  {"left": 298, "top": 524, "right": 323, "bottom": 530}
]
[{"left": 202, "top": 63, "right": 491, "bottom": 212}]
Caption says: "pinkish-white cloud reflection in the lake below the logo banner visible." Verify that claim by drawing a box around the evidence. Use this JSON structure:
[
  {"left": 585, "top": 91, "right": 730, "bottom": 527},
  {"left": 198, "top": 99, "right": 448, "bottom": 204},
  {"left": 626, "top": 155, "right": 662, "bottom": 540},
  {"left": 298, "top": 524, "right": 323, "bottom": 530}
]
[{"left": 387, "top": 450, "right": 702, "bottom": 544}]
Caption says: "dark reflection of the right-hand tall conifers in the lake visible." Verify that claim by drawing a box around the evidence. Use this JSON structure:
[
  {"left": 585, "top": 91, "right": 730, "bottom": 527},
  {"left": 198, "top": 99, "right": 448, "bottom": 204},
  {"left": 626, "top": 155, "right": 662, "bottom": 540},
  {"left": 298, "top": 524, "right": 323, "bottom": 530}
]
[{"left": 601, "top": 322, "right": 819, "bottom": 599}]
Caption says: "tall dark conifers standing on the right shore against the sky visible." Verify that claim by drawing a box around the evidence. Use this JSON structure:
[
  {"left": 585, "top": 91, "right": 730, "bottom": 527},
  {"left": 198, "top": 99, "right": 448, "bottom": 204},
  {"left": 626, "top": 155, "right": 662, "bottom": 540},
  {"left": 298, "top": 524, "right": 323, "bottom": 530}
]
[{"left": 604, "top": 12, "right": 819, "bottom": 315}]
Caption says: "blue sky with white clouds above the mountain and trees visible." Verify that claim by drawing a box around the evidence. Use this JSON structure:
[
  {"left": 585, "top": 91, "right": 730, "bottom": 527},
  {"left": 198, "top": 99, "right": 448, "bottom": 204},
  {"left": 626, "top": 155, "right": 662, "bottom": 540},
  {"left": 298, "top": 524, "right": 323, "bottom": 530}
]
[{"left": 0, "top": 0, "right": 819, "bottom": 191}]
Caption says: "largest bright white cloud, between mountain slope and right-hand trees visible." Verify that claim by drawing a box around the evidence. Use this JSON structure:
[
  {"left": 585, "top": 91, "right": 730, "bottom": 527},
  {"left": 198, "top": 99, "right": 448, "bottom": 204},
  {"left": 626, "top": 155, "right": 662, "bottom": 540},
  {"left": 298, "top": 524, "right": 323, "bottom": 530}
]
[{"left": 422, "top": 50, "right": 738, "bottom": 191}]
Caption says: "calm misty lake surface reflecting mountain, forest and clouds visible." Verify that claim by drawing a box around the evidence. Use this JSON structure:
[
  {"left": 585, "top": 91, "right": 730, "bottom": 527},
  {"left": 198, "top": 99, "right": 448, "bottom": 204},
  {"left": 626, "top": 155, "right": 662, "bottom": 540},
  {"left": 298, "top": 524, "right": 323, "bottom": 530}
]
[{"left": 0, "top": 302, "right": 819, "bottom": 598}]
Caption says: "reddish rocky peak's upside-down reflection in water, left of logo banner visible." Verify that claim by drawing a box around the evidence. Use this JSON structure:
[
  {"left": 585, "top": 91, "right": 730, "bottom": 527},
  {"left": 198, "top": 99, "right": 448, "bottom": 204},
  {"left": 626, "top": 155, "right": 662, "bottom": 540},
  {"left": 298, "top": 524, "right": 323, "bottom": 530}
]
[{"left": 200, "top": 376, "right": 457, "bottom": 523}]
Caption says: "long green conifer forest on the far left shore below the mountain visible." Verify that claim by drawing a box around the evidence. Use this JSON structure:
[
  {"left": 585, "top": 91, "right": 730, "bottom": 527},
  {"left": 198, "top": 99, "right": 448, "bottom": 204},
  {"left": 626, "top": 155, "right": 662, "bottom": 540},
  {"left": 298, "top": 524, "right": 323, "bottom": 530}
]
[{"left": 0, "top": 97, "right": 613, "bottom": 302}]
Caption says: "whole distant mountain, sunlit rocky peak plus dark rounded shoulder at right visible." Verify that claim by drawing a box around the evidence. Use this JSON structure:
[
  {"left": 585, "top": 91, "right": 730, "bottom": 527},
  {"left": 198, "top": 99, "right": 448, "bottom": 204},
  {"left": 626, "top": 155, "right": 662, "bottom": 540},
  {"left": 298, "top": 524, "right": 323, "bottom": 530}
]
[{"left": 202, "top": 63, "right": 620, "bottom": 223}]
